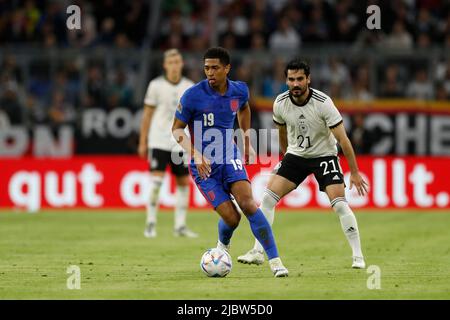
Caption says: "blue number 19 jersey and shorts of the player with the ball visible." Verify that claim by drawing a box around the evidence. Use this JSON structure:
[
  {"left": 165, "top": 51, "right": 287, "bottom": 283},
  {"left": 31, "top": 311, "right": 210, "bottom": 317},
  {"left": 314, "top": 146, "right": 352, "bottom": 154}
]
[{"left": 175, "top": 80, "right": 249, "bottom": 208}]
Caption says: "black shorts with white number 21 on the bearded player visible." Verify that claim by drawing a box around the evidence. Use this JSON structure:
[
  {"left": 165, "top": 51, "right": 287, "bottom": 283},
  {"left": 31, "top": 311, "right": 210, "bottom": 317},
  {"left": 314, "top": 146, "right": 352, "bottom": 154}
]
[{"left": 274, "top": 153, "right": 344, "bottom": 191}]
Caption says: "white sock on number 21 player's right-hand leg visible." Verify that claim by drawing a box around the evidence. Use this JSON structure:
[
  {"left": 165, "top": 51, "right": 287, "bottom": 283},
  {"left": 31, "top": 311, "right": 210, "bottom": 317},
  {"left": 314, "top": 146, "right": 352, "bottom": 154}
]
[{"left": 331, "top": 197, "right": 363, "bottom": 257}]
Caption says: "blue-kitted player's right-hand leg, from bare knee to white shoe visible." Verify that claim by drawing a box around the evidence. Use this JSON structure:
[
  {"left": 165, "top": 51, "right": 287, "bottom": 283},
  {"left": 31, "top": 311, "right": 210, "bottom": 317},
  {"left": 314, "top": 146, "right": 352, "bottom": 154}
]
[{"left": 231, "top": 180, "right": 289, "bottom": 277}]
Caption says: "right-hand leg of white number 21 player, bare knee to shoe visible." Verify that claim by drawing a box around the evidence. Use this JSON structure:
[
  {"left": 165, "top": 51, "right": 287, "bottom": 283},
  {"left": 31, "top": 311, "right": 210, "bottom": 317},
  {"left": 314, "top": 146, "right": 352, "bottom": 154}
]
[{"left": 325, "top": 184, "right": 366, "bottom": 269}]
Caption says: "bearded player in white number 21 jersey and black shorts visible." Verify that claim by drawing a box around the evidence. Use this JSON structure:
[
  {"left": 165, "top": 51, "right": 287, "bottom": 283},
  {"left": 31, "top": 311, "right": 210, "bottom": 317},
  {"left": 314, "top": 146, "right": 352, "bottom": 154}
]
[{"left": 238, "top": 59, "right": 368, "bottom": 269}]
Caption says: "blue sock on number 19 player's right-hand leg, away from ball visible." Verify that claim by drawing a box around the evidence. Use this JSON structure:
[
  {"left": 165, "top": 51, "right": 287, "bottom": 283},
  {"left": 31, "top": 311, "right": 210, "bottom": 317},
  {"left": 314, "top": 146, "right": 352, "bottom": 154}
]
[{"left": 247, "top": 208, "right": 279, "bottom": 260}]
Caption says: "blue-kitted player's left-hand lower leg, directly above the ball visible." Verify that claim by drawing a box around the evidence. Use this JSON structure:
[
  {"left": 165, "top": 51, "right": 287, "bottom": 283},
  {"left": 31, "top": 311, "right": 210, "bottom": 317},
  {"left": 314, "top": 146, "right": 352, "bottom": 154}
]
[{"left": 216, "top": 201, "right": 241, "bottom": 251}]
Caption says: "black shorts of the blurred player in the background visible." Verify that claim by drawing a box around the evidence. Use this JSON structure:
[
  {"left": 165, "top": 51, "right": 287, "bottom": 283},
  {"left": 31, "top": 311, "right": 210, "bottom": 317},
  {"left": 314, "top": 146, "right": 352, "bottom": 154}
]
[{"left": 148, "top": 149, "right": 189, "bottom": 177}]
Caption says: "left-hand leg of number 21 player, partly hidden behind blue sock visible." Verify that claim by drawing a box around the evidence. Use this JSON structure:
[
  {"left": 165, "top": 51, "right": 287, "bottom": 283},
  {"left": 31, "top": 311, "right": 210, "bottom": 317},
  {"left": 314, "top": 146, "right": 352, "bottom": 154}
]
[{"left": 238, "top": 175, "right": 297, "bottom": 265}]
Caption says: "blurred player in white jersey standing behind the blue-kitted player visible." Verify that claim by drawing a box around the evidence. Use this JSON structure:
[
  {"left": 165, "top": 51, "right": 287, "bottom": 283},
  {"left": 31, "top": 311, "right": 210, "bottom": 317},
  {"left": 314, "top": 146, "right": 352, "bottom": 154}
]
[{"left": 138, "top": 49, "right": 198, "bottom": 238}]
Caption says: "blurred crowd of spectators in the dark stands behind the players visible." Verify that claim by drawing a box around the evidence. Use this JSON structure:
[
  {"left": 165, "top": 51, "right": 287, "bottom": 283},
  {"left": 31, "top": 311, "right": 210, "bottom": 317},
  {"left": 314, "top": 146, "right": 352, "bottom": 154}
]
[{"left": 0, "top": 0, "right": 450, "bottom": 152}]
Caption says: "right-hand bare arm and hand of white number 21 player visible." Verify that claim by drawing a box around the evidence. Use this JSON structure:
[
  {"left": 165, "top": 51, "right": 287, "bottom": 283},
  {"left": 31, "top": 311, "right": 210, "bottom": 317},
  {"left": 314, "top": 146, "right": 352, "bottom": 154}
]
[{"left": 331, "top": 123, "right": 369, "bottom": 196}]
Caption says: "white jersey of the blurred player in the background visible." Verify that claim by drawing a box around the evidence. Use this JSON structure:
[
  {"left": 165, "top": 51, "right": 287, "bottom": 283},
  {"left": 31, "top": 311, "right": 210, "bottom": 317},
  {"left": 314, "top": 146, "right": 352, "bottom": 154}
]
[{"left": 144, "top": 76, "right": 194, "bottom": 152}]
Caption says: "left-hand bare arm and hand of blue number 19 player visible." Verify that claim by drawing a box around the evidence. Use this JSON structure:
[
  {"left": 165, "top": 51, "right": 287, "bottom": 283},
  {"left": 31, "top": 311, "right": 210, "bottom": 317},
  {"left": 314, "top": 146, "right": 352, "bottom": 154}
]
[{"left": 172, "top": 118, "right": 211, "bottom": 179}]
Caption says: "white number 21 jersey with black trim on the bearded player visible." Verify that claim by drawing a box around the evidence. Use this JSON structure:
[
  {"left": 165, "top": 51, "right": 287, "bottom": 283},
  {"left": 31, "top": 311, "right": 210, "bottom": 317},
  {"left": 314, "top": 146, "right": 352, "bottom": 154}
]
[{"left": 273, "top": 88, "right": 342, "bottom": 158}]
